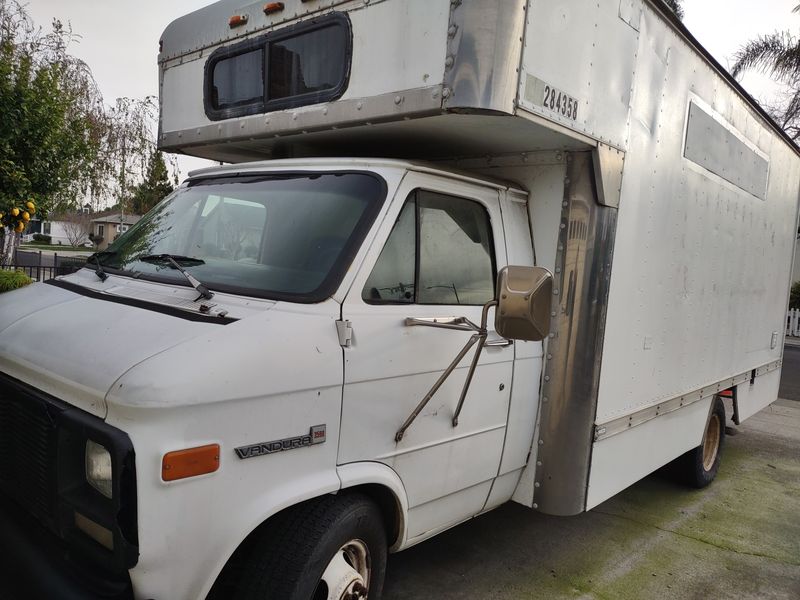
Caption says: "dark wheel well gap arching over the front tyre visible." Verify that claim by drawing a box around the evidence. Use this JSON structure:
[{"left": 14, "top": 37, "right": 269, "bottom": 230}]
[{"left": 206, "top": 484, "right": 402, "bottom": 600}]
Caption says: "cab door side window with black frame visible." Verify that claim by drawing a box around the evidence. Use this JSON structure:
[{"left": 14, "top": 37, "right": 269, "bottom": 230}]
[{"left": 362, "top": 190, "right": 496, "bottom": 305}]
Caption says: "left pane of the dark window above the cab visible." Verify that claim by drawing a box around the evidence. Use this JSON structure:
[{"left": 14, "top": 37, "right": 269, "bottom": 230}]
[{"left": 211, "top": 48, "right": 264, "bottom": 109}]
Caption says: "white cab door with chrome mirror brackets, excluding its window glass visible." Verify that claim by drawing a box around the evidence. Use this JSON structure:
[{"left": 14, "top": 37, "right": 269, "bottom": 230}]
[{"left": 339, "top": 172, "right": 514, "bottom": 536}]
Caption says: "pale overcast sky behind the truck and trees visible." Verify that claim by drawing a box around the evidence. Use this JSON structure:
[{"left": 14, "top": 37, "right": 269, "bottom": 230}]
[{"left": 27, "top": 0, "right": 800, "bottom": 176}]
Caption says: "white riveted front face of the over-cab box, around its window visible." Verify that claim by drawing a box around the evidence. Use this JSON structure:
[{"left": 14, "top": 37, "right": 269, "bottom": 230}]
[{"left": 159, "top": 0, "right": 451, "bottom": 155}]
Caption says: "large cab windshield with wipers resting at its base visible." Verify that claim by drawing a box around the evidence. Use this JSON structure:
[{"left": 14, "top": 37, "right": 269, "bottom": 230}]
[{"left": 97, "top": 172, "right": 386, "bottom": 302}]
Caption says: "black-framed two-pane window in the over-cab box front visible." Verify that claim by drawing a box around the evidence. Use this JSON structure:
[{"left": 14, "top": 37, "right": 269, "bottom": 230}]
[{"left": 204, "top": 13, "right": 352, "bottom": 120}]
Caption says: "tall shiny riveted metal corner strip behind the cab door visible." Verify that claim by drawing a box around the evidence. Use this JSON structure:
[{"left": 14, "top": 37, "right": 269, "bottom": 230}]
[{"left": 534, "top": 152, "right": 617, "bottom": 515}]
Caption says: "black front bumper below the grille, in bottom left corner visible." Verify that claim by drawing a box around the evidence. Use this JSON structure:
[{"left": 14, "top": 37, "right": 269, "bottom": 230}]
[{"left": 0, "top": 492, "right": 133, "bottom": 600}]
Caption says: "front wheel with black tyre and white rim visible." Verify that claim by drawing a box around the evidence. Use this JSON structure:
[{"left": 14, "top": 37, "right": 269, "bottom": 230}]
[{"left": 227, "top": 494, "right": 387, "bottom": 600}]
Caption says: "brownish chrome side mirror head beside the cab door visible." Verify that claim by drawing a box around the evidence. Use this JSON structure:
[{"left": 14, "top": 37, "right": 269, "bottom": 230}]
[{"left": 494, "top": 266, "right": 553, "bottom": 342}]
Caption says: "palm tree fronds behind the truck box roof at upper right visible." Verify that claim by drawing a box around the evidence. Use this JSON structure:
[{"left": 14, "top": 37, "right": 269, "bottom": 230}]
[{"left": 731, "top": 4, "right": 800, "bottom": 141}]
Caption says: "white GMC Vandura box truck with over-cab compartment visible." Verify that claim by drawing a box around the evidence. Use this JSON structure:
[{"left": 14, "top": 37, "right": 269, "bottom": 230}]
[{"left": 0, "top": 0, "right": 800, "bottom": 600}]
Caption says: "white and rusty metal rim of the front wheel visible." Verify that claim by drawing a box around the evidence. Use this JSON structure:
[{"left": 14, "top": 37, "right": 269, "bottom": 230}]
[{"left": 314, "top": 540, "right": 370, "bottom": 600}]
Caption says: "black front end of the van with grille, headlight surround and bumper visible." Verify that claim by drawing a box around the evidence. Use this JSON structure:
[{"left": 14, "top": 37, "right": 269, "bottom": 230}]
[{"left": 0, "top": 373, "right": 138, "bottom": 599}]
